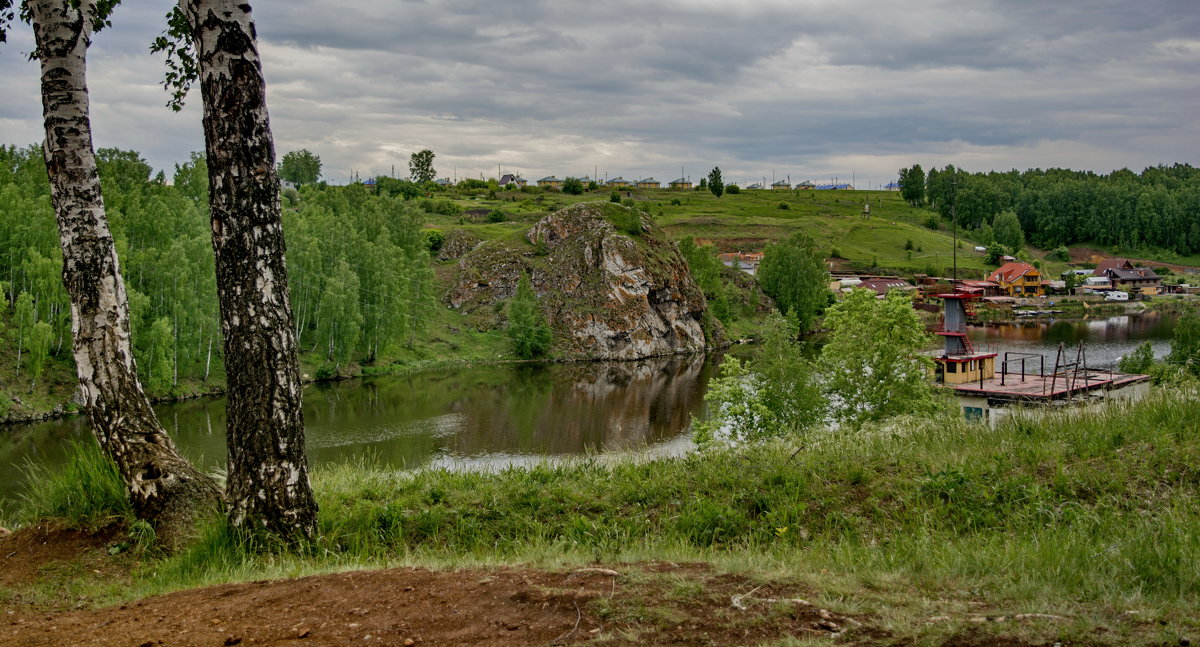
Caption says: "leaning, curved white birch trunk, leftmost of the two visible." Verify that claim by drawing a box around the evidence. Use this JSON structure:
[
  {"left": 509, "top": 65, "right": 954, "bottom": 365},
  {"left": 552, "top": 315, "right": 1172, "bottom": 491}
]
[{"left": 29, "top": 0, "right": 221, "bottom": 546}]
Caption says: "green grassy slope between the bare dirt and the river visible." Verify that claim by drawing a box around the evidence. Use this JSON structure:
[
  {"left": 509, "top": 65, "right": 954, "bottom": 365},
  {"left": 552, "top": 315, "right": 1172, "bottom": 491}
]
[{"left": 14, "top": 387, "right": 1200, "bottom": 645}]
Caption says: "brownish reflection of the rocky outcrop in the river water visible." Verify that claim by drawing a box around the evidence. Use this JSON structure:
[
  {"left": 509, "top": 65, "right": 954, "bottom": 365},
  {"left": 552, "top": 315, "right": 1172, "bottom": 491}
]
[{"left": 448, "top": 355, "right": 708, "bottom": 455}]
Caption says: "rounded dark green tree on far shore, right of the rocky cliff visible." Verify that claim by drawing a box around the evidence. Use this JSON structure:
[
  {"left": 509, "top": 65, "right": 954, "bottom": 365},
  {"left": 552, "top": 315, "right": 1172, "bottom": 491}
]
[{"left": 757, "top": 233, "right": 829, "bottom": 331}]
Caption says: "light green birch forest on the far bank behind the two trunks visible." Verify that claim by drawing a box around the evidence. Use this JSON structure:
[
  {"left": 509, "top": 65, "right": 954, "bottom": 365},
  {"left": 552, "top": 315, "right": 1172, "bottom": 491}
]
[{"left": 0, "top": 146, "right": 436, "bottom": 395}]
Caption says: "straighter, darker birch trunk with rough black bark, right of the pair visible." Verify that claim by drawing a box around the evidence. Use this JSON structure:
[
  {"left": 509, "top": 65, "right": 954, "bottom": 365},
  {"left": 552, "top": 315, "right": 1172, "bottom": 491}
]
[{"left": 180, "top": 0, "right": 317, "bottom": 539}]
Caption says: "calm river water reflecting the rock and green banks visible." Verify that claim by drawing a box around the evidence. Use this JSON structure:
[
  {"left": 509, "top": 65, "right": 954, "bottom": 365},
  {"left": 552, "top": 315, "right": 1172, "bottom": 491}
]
[{"left": 0, "top": 312, "right": 1177, "bottom": 508}]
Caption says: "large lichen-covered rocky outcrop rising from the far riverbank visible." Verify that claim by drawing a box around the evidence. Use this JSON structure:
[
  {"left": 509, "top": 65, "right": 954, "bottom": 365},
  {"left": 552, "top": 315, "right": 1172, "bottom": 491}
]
[{"left": 446, "top": 202, "right": 725, "bottom": 359}]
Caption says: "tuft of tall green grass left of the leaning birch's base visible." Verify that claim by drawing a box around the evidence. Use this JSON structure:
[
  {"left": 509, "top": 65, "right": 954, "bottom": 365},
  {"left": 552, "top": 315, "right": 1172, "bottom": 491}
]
[{"left": 17, "top": 439, "right": 133, "bottom": 528}]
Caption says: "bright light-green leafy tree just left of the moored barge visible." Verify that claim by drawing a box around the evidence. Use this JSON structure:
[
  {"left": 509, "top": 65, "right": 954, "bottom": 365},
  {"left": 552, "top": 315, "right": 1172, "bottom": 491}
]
[{"left": 818, "top": 289, "right": 938, "bottom": 426}]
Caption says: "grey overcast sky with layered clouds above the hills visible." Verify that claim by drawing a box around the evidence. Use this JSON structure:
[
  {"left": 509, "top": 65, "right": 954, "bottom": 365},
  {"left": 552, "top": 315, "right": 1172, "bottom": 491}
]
[{"left": 0, "top": 0, "right": 1200, "bottom": 188}]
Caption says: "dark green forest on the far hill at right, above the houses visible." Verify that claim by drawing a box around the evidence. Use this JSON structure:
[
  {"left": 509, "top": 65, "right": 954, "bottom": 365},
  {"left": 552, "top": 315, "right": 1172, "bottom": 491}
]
[{"left": 899, "top": 164, "right": 1200, "bottom": 256}]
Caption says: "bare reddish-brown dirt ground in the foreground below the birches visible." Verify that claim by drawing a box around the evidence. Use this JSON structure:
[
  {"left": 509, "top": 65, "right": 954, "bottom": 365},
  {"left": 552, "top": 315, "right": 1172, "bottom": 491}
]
[{"left": 0, "top": 528, "right": 884, "bottom": 647}]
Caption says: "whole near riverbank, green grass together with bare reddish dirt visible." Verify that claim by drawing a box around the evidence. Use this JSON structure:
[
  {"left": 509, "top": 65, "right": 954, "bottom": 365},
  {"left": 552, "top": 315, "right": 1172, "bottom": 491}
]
[{"left": 0, "top": 387, "right": 1200, "bottom": 646}]
